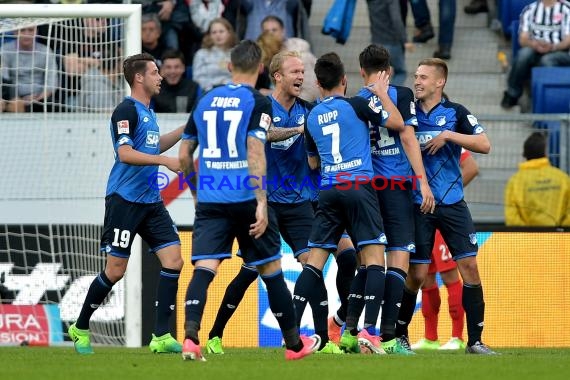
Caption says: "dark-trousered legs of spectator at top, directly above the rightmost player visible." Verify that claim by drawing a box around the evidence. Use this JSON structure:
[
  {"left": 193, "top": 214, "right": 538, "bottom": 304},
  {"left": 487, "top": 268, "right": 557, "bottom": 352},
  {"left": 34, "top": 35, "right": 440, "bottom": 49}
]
[{"left": 403, "top": 0, "right": 457, "bottom": 59}]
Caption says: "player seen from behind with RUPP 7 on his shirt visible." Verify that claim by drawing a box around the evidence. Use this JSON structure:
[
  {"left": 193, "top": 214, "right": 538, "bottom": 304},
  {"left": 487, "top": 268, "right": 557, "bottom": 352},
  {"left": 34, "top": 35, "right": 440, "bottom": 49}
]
[{"left": 293, "top": 53, "right": 404, "bottom": 352}]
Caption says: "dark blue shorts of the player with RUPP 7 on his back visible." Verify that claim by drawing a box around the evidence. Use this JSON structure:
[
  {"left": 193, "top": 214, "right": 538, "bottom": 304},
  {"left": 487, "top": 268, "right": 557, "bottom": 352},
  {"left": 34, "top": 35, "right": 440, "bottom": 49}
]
[{"left": 309, "top": 183, "right": 386, "bottom": 252}]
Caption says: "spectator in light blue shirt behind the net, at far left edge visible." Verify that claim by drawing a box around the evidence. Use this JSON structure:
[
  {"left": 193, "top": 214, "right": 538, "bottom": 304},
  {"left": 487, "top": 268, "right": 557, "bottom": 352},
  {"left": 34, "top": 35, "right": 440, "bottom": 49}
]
[{"left": 0, "top": 26, "right": 58, "bottom": 112}]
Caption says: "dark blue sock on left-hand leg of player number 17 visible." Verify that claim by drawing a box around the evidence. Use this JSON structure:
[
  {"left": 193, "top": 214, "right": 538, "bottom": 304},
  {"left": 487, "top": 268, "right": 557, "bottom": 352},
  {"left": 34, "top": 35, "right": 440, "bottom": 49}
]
[{"left": 184, "top": 267, "right": 216, "bottom": 344}]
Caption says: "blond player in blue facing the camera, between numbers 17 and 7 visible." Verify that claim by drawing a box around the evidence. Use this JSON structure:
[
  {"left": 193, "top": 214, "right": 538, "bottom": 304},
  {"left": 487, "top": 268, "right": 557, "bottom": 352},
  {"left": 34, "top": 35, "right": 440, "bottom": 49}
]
[{"left": 202, "top": 51, "right": 342, "bottom": 354}]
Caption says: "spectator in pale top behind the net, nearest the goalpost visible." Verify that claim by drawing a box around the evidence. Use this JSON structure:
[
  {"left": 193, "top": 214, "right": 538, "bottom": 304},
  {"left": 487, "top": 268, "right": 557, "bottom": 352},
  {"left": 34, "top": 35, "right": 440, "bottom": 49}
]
[{"left": 79, "top": 44, "right": 126, "bottom": 112}]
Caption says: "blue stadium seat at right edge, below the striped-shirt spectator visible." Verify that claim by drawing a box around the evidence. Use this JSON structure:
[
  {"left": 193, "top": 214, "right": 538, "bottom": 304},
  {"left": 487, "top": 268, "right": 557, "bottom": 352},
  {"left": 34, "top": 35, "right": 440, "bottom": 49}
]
[{"left": 531, "top": 67, "right": 570, "bottom": 167}]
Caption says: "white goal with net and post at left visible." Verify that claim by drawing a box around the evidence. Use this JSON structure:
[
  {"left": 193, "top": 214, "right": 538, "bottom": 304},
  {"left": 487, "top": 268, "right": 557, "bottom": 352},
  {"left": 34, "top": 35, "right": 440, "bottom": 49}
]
[{"left": 0, "top": 4, "right": 141, "bottom": 346}]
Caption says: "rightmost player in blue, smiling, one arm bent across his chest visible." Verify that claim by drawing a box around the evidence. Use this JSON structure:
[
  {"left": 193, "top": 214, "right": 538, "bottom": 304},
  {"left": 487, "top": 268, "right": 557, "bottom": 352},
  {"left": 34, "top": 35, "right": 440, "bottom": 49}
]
[{"left": 396, "top": 58, "right": 495, "bottom": 355}]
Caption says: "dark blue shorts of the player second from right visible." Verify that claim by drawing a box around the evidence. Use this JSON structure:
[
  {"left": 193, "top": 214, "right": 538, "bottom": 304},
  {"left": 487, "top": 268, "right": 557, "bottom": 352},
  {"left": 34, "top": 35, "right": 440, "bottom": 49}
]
[{"left": 376, "top": 181, "right": 416, "bottom": 252}]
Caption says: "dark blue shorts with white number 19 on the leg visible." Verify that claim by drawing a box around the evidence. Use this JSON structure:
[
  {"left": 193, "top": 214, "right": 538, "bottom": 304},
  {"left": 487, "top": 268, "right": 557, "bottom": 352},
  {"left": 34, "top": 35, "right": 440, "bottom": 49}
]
[{"left": 101, "top": 194, "right": 180, "bottom": 258}]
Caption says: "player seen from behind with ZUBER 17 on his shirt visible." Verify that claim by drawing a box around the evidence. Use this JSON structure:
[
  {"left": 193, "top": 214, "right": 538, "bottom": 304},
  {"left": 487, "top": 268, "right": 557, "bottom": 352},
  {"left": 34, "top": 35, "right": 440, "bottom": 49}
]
[{"left": 179, "top": 40, "right": 320, "bottom": 360}]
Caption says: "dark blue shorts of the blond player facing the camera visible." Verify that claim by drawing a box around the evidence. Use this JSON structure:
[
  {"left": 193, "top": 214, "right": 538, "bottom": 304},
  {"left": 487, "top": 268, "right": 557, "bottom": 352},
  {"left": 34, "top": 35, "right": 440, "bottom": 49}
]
[{"left": 269, "top": 201, "right": 315, "bottom": 258}]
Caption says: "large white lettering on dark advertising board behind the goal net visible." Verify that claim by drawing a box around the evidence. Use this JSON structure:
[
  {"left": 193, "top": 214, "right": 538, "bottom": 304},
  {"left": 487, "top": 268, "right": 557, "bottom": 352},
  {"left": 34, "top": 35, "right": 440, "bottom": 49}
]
[{"left": 0, "top": 262, "right": 125, "bottom": 322}]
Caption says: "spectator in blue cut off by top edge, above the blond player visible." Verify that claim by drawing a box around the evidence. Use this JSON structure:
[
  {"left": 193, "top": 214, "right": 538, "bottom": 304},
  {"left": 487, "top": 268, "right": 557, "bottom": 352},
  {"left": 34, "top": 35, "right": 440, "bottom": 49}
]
[{"left": 241, "top": 0, "right": 300, "bottom": 40}]
